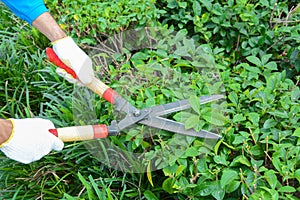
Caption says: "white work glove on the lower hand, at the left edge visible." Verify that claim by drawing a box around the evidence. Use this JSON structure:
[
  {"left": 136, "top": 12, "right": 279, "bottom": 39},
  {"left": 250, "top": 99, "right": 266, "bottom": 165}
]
[{"left": 0, "top": 118, "right": 64, "bottom": 164}]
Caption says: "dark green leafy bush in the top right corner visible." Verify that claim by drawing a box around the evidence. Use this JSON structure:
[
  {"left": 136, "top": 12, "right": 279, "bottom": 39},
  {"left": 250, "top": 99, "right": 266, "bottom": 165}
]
[{"left": 157, "top": 0, "right": 300, "bottom": 72}]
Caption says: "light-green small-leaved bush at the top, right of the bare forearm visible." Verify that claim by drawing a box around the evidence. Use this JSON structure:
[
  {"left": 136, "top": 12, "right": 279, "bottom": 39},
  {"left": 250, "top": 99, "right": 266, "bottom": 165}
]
[{"left": 46, "top": 0, "right": 163, "bottom": 45}]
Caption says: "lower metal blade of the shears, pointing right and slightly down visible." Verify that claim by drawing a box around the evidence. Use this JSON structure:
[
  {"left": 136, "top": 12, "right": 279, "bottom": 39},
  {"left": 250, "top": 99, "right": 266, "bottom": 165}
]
[{"left": 138, "top": 116, "right": 222, "bottom": 139}]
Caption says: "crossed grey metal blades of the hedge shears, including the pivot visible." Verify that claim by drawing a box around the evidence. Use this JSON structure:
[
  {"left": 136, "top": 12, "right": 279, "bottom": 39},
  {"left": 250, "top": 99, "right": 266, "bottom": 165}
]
[{"left": 109, "top": 95, "right": 224, "bottom": 139}]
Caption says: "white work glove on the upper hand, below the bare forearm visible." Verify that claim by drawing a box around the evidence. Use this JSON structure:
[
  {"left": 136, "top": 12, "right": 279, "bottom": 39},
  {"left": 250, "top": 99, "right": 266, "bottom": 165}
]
[{"left": 52, "top": 37, "right": 94, "bottom": 85}]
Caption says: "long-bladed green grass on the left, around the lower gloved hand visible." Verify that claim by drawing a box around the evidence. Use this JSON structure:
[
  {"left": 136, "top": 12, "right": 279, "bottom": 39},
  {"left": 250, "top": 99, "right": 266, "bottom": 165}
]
[{"left": 0, "top": 3, "right": 159, "bottom": 200}]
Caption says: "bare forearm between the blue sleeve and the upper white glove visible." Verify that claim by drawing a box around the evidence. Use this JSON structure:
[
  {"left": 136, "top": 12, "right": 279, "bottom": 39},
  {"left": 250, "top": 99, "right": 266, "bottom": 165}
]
[{"left": 32, "top": 12, "right": 67, "bottom": 42}]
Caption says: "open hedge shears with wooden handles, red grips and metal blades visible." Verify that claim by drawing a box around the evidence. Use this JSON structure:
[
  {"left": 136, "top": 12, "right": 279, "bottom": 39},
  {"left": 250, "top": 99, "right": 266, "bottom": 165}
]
[{"left": 46, "top": 48, "right": 224, "bottom": 142}]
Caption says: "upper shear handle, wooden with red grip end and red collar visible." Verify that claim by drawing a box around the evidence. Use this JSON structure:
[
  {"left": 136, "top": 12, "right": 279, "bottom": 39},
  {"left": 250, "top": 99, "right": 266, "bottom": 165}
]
[{"left": 46, "top": 48, "right": 119, "bottom": 104}]
